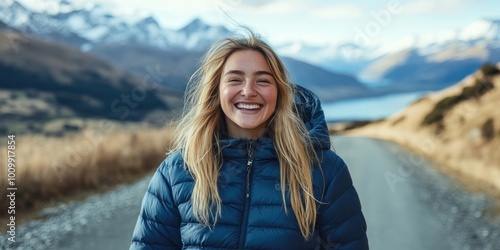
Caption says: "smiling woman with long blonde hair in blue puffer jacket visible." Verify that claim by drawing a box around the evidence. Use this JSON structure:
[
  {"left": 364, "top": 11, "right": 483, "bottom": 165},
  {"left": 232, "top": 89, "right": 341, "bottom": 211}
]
[{"left": 130, "top": 34, "right": 368, "bottom": 249}]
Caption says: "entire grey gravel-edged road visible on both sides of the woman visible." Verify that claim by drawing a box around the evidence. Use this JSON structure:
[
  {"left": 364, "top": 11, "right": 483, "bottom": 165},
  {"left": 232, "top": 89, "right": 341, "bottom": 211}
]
[{"left": 0, "top": 137, "right": 500, "bottom": 250}]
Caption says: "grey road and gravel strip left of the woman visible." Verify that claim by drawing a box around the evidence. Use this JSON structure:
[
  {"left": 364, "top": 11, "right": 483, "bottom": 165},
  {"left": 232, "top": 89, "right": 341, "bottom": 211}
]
[{"left": 0, "top": 176, "right": 151, "bottom": 250}]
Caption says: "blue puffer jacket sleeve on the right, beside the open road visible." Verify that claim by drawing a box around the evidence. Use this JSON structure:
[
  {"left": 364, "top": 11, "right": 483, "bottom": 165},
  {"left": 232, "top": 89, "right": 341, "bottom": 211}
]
[{"left": 317, "top": 150, "right": 368, "bottom": 250}]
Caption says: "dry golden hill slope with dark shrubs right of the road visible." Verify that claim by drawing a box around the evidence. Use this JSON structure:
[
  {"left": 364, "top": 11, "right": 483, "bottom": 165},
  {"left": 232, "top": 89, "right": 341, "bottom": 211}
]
[{"left": 349, "top": 62, "right": 500, "bottom": 194}]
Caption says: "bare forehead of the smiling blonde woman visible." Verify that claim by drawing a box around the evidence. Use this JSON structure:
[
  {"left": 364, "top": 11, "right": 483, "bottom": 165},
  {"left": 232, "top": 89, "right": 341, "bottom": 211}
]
[{"left": 223, "top": 50, "right": 271, "bottom": 72}]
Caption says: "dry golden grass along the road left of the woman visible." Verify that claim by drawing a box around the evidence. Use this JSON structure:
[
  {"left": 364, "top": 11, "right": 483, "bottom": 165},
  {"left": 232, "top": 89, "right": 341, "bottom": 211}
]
[{"left": 0, "top": 123, "right": 174, "bottom": 217}]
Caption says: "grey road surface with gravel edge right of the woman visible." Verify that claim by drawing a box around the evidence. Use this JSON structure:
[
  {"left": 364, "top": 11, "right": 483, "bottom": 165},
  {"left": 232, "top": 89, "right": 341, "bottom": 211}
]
[{"left": 333, "top": 137, "right": 500, "bottom": 250}]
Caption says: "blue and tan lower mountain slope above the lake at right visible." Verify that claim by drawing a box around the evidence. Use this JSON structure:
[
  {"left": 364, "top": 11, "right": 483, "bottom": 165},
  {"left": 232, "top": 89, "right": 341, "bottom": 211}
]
[{"left": 361, "top": 43, "right": 500, "bottom": 90}]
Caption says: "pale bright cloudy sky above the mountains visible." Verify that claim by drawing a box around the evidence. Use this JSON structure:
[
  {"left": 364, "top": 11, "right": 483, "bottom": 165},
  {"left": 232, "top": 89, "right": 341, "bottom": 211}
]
[{"left": 15, "top": 0, "right": 500, "bottom": 46}]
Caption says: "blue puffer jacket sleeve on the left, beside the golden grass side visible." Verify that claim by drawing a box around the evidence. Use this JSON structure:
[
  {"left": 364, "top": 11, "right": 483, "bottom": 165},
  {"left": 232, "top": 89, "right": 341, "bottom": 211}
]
[{"left": 130, "top": 158, "right": 182, "bottom": 250}]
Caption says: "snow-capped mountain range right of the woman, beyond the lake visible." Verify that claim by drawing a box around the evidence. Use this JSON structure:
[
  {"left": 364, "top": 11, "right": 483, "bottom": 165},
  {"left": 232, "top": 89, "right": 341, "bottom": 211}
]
[{"left": 278, "top": 19, "right": 500, "bottom": 87}]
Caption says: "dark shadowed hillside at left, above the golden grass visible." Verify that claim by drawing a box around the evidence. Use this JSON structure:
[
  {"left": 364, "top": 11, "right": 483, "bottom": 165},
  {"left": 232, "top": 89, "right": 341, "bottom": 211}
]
[{"left": 0, "top": 32, "right": 181, "bottom": 134}]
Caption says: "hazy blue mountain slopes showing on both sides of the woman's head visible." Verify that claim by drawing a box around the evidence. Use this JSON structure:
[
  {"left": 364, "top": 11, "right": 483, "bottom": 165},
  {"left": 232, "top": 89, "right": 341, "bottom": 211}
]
[{"left": 89, "top": 44, "right": 372, "bottom": 102}]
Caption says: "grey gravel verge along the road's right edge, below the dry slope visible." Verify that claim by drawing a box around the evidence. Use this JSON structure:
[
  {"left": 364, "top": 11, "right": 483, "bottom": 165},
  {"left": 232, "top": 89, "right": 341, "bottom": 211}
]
[{"left": 406, "top": 149, "right": 500, "bottom": 250}]
